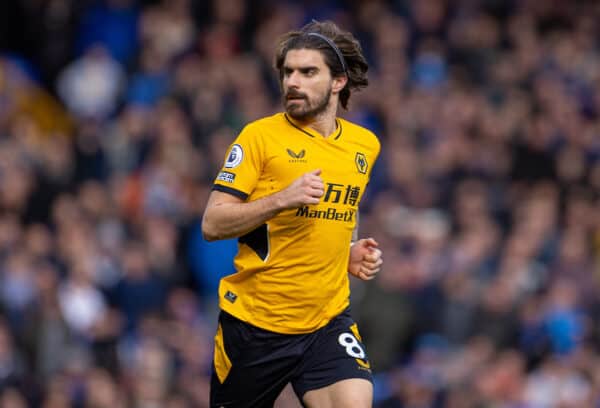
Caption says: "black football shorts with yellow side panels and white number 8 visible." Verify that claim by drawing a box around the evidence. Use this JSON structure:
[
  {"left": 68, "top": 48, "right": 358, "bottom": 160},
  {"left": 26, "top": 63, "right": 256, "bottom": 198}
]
[{"left": 210, "top": 310, "right": 373, "bottom": 408}]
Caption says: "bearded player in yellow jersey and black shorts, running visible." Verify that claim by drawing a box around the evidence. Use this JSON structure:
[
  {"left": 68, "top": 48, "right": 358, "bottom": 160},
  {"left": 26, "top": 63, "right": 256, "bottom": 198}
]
[{"left": 202, "top": 21, "right": 382, "bottom": 408}]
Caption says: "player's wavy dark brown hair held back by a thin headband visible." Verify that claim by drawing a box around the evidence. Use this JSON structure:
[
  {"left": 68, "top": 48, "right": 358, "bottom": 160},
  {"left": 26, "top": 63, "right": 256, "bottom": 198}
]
[{"left": 275, "top": 20, "right": 369, "bottom": 109}]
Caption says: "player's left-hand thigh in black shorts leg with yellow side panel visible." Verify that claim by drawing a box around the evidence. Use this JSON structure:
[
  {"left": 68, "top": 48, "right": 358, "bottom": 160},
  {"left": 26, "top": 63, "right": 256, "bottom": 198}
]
[{"left": 210, "top": 313, "right": 303, "bottom": 408}]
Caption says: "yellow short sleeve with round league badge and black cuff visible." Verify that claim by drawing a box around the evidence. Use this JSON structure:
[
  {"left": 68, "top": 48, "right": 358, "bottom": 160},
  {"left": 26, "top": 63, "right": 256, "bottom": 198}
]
[{"left": 213, "top": 124, "right": 264, "bottom": 200}]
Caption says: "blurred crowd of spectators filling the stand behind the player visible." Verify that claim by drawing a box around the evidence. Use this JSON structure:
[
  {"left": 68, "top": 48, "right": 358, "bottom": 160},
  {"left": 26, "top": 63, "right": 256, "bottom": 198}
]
[{"left": 0, "top": 0, "right": 600, "bottom": 408}]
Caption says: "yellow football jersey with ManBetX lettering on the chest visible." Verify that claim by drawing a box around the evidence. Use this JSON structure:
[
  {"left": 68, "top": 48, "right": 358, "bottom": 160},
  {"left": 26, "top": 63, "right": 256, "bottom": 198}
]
[{"left": 213, "top": 113, "right": 380, "bottom": 334}]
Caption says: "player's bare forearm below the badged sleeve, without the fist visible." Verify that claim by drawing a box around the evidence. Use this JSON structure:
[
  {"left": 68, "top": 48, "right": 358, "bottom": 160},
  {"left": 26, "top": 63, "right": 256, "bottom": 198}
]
[{"left": 202, "top": 194, "right": 283, "bottom": 241}]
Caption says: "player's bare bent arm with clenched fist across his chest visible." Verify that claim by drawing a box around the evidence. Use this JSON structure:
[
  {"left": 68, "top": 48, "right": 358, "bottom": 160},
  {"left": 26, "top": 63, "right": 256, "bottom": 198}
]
[{"left": 202, "top": 170, "right": 324, "bottom": 241}]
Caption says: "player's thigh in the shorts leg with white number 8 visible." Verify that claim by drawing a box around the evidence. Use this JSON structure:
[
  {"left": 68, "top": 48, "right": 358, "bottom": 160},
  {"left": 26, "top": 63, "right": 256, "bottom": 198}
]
[{"left": 292, "top": 311, "right": 373, "bottom": 407}]
